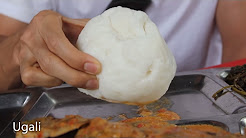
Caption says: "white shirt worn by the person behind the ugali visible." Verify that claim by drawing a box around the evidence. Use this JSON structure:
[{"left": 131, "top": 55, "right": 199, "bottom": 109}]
[{"left": 0, "top": 0, "right": 222, "bottom": 71}]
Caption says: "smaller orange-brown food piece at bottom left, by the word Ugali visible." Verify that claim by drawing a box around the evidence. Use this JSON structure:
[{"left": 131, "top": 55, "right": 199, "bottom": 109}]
[{"left": 16, "top": 115, "right": 89, "bottom": 138}]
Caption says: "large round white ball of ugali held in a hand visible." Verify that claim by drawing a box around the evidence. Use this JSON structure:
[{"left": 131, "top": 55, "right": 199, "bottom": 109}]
[{"left": 77, "top": 7, "right": 176, "bottom": 104}]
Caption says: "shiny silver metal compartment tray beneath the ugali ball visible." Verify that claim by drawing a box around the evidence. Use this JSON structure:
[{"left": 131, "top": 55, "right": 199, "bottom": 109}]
[{"left": 0, "top": 68, "right": 246, "bottom": 137}]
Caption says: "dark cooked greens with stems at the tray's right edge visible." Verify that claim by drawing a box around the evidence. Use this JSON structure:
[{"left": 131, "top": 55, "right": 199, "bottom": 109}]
[{"left": 213, "top": 64, "right": 246, "bottom": 100}]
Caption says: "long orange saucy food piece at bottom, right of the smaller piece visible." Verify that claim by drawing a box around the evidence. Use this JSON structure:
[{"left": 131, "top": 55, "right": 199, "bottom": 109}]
[{"left": 75, "top": 117, "right": 243, "bottom": 138}]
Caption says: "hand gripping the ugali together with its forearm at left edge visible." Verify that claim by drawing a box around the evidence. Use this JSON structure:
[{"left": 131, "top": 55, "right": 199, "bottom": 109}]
[{"left": 0, "top": 11, "right": 101, "bottom": 91}]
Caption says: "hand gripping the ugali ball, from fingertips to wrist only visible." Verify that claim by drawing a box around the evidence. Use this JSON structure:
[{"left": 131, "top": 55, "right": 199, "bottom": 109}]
[{"left": 17, "top": 11, "right": 101, "bottom": 89}]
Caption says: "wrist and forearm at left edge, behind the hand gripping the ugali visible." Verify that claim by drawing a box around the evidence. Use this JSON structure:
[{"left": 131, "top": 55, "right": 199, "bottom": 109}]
[{"left": 0, "top": 33, "right": 22, "bottom": 93}]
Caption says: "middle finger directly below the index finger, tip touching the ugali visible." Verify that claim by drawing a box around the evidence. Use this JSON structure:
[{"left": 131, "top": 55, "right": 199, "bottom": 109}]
[{"left": 20, "top": 33, "right": 98, "bottom": 89}]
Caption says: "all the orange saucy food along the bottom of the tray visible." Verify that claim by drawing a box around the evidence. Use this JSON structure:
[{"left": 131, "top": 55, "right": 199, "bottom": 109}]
[{"left": 17, "top": 109, "right": 242, "bottom": 138}]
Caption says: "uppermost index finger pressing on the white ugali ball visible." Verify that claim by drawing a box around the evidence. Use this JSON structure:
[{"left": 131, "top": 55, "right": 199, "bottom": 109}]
[{"left": 39, "top": 14, "right": 101, "bottom": 74}]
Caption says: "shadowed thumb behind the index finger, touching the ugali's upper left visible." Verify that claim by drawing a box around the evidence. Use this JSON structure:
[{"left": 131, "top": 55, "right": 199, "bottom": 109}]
[{"left": 62, "top": 17, "right": 90, "bottom": 45}]
